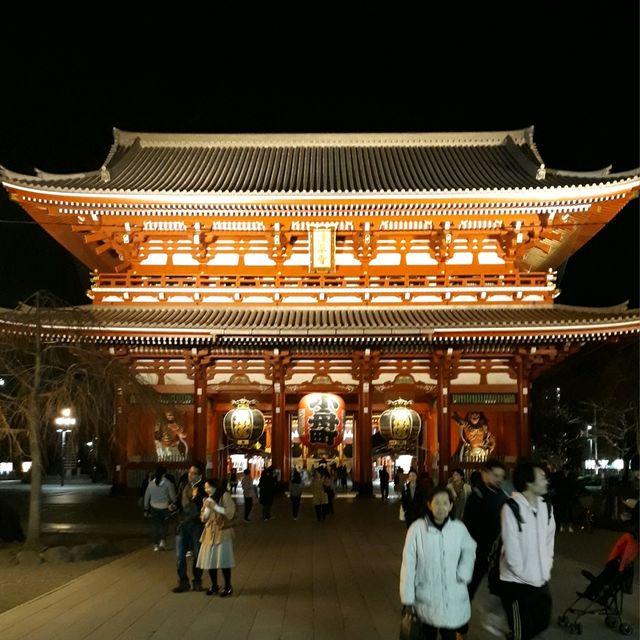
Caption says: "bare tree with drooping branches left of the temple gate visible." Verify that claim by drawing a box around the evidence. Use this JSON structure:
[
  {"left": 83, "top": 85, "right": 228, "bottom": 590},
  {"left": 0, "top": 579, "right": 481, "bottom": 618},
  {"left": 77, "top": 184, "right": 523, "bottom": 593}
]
[{"left": 0, "top": 293, "right": 157, "bottom": 549}]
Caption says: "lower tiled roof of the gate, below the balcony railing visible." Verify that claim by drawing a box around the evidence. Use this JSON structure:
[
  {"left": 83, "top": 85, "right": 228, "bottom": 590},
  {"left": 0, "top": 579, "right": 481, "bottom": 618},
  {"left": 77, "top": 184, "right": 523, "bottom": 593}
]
[{"left": 0, "top": 305, "right": 640, "bottom": 346}]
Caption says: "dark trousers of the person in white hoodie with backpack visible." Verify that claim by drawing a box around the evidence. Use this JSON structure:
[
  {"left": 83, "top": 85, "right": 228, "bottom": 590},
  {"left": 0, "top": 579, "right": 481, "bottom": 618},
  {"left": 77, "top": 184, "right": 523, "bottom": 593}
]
[{"left": 502, "top": 582, "right": 551, "bottom": 640}]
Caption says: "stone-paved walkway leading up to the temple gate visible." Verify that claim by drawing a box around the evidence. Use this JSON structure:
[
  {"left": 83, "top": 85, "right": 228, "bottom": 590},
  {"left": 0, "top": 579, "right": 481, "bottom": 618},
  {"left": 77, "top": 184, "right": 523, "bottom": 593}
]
[{"left": 0, "top": 485, "right": 638, "bottom": 640}]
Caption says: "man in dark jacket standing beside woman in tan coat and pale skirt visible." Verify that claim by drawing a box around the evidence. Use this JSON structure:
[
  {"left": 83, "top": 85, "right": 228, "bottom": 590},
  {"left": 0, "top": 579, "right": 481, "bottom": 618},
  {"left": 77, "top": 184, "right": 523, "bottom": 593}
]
[{"left": 173, "top": 462, "right": 206, "bottom": 593}]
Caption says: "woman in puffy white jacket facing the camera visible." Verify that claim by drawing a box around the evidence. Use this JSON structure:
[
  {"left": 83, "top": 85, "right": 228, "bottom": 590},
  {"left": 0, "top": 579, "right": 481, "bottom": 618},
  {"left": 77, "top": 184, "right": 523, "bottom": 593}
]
[{"left": 400, "top": 486, "right": 476, "bottom": 640}]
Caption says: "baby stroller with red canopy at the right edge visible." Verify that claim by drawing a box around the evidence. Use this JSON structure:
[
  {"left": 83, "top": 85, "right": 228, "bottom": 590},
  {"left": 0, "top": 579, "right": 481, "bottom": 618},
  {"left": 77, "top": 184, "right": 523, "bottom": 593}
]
[{"left": 558, "top": 533, "right": 638, "bottom": 636}]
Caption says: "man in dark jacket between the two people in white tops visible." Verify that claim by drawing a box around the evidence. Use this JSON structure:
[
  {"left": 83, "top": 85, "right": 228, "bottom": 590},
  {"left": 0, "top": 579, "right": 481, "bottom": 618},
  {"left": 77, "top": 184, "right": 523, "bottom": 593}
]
[{"left": 464, "top": 458, "right": 508, "bottom": 600}]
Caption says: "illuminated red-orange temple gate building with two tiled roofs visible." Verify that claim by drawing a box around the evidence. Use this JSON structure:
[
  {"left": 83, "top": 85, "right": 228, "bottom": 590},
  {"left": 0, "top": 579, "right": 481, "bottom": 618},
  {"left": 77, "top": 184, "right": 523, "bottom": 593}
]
[{"left": 2, "top": 129, "right": 640, "bottom": 492}]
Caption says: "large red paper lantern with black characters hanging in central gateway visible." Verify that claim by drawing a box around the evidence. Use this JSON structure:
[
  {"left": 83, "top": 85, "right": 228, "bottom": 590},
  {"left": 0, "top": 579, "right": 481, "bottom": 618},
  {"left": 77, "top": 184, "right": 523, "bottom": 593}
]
[{"left": 298, "top": 393, "right": 345, "bottom": 447}]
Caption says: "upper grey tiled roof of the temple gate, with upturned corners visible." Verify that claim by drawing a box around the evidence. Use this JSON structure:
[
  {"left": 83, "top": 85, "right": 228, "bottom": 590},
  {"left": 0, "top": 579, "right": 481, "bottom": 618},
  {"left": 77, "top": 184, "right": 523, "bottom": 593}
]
[{"left": 0, "top": 128, "right": 639, "bottom": 195}]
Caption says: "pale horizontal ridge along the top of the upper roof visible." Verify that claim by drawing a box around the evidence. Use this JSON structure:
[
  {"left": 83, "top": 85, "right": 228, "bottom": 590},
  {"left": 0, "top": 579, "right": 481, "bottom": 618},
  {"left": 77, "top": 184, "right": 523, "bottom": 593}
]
[{"left": 113, "top": 127, "right": 533, "bottom": 147}]
